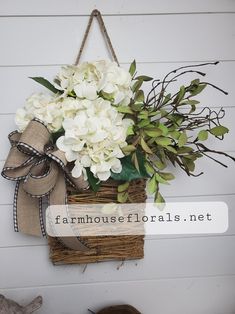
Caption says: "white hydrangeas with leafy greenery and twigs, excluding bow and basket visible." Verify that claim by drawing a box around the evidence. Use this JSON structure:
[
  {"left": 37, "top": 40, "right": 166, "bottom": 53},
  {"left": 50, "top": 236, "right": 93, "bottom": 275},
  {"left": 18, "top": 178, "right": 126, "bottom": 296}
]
[{"left": 15, "top": 60, "right": 234, "bottom": 202}]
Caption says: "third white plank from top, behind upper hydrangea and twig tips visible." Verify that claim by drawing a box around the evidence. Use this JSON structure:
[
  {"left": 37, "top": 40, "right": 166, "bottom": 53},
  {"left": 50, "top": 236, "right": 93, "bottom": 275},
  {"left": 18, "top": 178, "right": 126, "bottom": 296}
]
[{"left": 0, "top": 61, "right": 235, "bottom": 114}]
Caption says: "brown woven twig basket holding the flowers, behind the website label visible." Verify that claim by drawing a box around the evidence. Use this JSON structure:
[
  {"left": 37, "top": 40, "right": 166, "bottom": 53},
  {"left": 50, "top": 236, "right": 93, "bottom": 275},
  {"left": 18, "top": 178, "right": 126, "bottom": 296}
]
[{"left": 48, "top": 179, "right": 146, "bottom": 265}]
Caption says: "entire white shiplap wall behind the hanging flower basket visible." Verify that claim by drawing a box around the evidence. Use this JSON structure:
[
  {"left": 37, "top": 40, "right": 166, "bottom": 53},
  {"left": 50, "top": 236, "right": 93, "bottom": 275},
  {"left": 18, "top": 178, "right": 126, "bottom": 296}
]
[{"left": 0, "top": 0, "right": 235, "bottom": 314}]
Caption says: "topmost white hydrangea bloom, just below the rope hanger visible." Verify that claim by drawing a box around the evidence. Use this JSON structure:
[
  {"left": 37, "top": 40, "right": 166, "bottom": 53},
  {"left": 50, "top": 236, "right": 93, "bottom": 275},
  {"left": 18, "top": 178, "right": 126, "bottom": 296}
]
[{"left": 56, "top": 60, "right": 132, "bottom": 105}]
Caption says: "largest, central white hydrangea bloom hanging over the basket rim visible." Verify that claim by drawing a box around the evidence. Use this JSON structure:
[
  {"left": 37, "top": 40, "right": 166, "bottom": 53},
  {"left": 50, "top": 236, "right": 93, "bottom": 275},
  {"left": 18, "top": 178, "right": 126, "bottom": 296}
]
[{"left": 56, "top": 98, "right": 131, "bottom": 181}]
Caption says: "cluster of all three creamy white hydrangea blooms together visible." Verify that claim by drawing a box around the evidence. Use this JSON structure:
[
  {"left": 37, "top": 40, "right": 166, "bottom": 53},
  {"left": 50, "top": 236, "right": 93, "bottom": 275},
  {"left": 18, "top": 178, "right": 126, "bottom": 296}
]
[{"left": 15, "top": 61, "right": 132, "bottom": 181}]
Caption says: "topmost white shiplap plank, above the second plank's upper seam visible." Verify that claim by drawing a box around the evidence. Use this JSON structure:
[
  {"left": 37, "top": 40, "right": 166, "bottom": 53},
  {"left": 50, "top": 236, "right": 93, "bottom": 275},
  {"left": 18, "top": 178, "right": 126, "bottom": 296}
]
[{"left": 0, "top": 0, "right": 235, "bottom": 16}]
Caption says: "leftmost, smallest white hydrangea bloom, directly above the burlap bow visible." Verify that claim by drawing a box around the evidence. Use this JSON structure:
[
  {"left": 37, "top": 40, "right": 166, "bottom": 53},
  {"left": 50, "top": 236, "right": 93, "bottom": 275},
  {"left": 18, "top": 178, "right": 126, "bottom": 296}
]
[{"left": 15, "top": 94, "right": 63, "bottom": 132}]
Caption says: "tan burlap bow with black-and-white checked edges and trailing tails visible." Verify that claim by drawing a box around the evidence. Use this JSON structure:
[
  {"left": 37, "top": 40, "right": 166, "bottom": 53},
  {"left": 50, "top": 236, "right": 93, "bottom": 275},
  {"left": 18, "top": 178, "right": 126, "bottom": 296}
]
[{"left": 2, "top": 119, "right": 88, "bottom": 251}]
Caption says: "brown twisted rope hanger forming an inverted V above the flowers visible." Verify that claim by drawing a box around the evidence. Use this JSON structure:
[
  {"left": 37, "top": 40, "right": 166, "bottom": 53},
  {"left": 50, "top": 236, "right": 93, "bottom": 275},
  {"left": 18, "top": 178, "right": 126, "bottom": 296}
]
[{"left": 75, "top": 9, "right": 119, "bottom": 65}]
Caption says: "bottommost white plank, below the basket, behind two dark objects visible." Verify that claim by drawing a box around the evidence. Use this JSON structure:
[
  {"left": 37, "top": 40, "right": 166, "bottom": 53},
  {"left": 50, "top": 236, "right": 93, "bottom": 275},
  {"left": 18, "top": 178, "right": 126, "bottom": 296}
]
[{"left": 0, "top": 273, "right": 235, "bottom": 314}]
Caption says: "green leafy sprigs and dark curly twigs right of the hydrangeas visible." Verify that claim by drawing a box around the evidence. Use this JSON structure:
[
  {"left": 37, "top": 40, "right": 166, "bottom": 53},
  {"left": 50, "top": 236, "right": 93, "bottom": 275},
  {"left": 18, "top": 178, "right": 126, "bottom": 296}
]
[{"left": 112, "top": 61, "right": 235, "bottom": 203}]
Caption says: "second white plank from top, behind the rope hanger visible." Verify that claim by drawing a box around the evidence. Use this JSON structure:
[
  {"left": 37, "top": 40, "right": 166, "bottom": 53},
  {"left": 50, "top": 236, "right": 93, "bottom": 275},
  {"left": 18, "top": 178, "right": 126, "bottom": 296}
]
[{"left": 0, "top": 13, "right": 235, "bottom": 65}]
